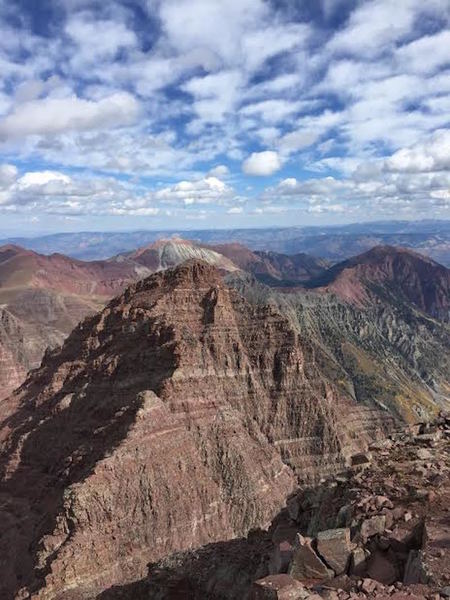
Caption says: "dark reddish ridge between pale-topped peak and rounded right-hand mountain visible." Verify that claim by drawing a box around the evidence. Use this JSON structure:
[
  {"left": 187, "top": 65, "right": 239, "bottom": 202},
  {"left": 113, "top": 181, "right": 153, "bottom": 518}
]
[{"left": 206, "top": 243, "right": 329, "bottom": 287}]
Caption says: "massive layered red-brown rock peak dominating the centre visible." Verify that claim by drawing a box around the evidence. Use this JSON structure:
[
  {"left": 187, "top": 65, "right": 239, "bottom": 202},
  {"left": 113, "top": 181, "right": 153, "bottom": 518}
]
[{"left": 0, "top": 262, "right": 390, "bottom": 599}]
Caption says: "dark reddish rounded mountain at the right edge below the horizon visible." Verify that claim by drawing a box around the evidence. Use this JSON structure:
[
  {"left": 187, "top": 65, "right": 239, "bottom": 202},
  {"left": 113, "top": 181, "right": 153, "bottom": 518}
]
[{"left": 311, "top": 246, "right": 450, "bottom": 321}]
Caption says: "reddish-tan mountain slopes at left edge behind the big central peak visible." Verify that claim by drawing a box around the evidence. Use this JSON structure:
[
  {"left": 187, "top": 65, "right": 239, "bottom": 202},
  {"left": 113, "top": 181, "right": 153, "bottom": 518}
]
[{"left": 0, "top": 245, "right": 149, "bottom": 399}]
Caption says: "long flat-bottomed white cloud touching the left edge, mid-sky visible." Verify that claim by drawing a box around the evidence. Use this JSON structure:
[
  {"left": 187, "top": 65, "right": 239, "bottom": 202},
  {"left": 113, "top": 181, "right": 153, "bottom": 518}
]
[{"left": 0, "top": 92, "right": 139, "bottom": 139}]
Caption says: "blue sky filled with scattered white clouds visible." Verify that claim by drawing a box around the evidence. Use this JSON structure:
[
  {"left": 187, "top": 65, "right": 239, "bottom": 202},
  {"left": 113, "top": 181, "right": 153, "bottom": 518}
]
[{"left": 0, "top": 0, "right": 450, "bottom": 235}]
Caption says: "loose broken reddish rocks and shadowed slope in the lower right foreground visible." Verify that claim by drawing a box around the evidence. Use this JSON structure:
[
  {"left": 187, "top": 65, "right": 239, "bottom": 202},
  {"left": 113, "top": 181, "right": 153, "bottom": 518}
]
[{"left": 138, "top": 416, "right": 450, "bottom": 600}]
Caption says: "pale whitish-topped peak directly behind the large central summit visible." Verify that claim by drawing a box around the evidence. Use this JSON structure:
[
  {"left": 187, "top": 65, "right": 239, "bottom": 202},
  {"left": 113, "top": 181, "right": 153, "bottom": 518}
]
[{"left": 113, "top": 237, "right": 237, "bottom": 273}]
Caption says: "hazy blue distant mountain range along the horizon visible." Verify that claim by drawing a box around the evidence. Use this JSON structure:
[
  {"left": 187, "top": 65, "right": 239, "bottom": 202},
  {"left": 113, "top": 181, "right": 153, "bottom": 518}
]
[{"left": 0, "top": 220, "right": 450, "bottom": 266}]
